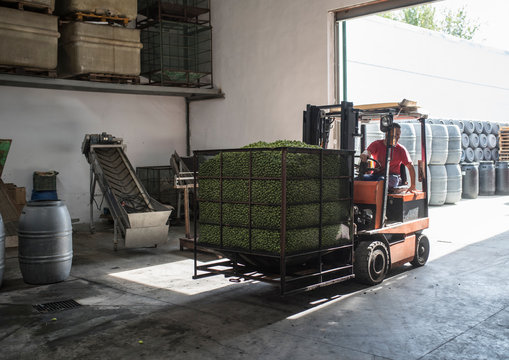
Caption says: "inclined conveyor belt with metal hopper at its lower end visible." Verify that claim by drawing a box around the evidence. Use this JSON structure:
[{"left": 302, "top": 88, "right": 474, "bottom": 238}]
[{"left": 83, "top": 133, "right": 172, "bottom": 247}]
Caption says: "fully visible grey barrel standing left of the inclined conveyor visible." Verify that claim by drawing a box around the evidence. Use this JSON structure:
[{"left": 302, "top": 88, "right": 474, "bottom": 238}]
[{"left": 18, "top": 201, "right": 73, "bottom": 284}]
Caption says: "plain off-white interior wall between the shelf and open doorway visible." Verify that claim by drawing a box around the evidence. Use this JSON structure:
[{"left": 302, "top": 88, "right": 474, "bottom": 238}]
[{"left": 191, "top": 0, "right": 362, "bottom": 149}]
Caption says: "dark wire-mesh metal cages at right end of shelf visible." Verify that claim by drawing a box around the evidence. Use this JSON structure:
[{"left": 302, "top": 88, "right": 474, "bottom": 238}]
[{"left": 136, "top": 0, "right": 213, "bottom": 87}]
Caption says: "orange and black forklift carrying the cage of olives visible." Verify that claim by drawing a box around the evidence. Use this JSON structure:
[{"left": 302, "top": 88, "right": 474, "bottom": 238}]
[{"left": 303, "top": 102, "right": 430, "bottom": 285}]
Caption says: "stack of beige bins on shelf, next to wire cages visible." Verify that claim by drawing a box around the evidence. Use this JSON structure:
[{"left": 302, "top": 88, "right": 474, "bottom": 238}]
[{"left": 56, "top": 0, "right": 142, "bottom": 84}]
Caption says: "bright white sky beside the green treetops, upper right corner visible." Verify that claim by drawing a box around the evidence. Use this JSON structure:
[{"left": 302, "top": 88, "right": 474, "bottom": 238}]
[{"left": 432, "top": 0, "right": 509, "bottom": 51}]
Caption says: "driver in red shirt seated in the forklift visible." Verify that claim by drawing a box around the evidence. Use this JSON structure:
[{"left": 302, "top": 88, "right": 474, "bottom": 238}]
[{"left": 360, "top": 123, "right": 415, "bottom": 192}]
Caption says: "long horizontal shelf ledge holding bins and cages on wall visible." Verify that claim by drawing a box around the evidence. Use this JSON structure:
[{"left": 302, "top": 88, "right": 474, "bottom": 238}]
[{"left": 0, "top": 74, "right": 224, "bottom": 101}]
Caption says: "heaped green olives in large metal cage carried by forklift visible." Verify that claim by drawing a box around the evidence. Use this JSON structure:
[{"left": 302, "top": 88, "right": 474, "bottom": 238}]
[{"left": 195, "top": 141, "right": 353, "bottom": 256}]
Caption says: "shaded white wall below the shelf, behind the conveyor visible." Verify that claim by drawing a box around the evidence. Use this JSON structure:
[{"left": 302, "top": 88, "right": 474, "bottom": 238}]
[{"left": 0, "top": 86, "right": 186, "bottom": 222}]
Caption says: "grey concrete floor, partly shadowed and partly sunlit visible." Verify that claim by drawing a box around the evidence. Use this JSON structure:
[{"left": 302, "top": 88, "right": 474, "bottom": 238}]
[{"left": 0, "top": 196, "right": 509, "bottom": 360}]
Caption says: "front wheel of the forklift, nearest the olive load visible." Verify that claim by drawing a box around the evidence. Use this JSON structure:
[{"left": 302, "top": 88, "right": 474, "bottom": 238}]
[{"left": 354, "top": 241, "right": 389, "bottom": 285}]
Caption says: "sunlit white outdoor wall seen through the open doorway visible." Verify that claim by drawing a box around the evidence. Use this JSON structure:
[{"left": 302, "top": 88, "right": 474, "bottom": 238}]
[{"left": 347, "top": 16, "right": 509, "bottom": 122}]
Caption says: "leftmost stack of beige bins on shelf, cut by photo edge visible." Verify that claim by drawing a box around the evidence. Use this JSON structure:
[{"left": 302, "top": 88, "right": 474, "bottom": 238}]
[{"left": 0, "top": 0, "right": 60, "bottom": 77}]
